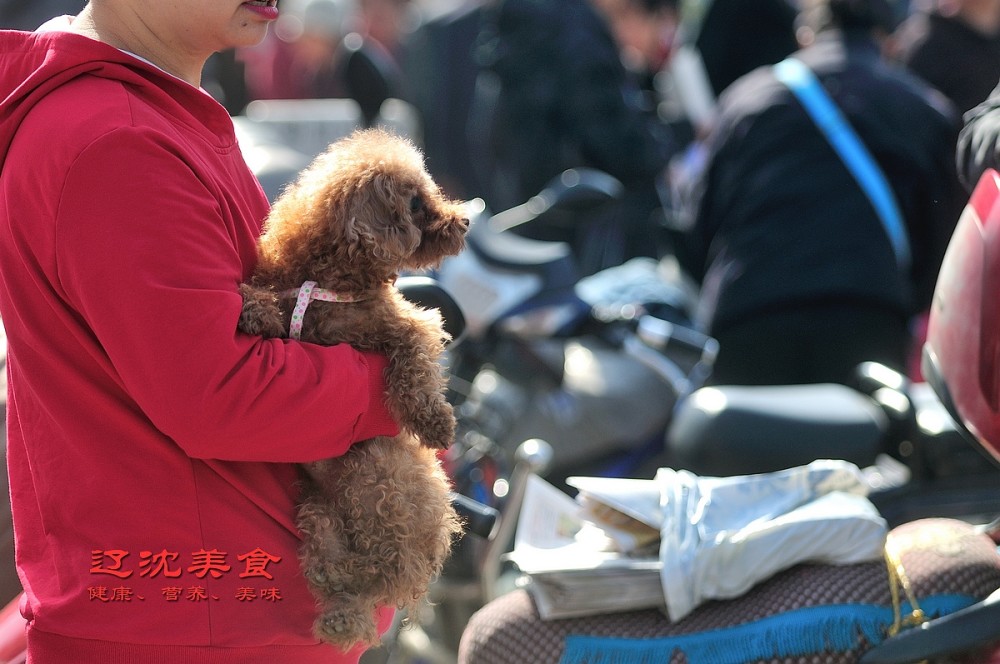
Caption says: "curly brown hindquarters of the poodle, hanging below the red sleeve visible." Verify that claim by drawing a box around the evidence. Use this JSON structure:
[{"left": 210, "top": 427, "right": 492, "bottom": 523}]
[{"left": 300, "top": 436, "right": 461, "bottom": 646}]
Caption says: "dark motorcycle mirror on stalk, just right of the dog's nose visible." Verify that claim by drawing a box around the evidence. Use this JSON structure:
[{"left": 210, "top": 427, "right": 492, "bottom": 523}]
[{"left": 489, "top": 168, "right": 625, "bottom": 231}]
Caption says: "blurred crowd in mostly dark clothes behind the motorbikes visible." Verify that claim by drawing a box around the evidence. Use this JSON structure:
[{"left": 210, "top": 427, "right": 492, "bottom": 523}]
[{"left": 0, "top": 0, "right": 1000, "bottom": 394}]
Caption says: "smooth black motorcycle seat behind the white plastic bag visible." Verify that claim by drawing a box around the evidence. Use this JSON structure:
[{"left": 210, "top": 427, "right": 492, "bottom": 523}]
[{"left": 666, "top": 384, "right": 889, "bottom": 476}]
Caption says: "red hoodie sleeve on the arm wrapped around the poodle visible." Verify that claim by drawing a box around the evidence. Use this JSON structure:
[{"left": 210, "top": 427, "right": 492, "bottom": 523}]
[{"left": 49, "top": 128, "right": 398, "bottom": 462}]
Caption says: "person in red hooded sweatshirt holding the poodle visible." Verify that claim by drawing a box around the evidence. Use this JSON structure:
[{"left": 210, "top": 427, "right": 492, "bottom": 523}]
[{"left": 0, "top": 0, "right": 406, "bottom": 664}]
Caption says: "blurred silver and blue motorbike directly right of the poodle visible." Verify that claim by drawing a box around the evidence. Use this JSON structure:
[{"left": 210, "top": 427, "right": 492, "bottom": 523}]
[{"left": 436, "top": 169, "right": 717, "bottom": 492}]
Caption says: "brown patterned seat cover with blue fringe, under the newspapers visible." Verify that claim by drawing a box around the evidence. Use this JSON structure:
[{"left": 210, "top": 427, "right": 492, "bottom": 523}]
[{"left": 459, "top": 519, "right": 1000, "bottom": 664}]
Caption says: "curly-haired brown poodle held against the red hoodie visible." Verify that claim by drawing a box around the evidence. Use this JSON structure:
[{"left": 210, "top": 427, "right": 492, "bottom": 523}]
[{"left": 240, "top": 130, "right": 468, "bottom": 650}]
